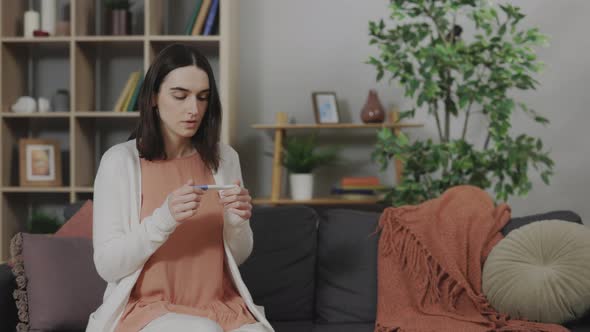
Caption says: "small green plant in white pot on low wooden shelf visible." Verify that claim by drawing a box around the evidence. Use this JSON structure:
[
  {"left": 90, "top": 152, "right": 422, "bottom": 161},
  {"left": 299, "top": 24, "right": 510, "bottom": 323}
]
[{"left": 282, "top": 136, "right": 337, "bottom": 200}]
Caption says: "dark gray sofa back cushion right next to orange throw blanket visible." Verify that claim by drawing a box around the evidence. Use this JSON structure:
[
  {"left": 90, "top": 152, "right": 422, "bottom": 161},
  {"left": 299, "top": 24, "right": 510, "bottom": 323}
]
[{"left": 316, "top": 209, "right": 380, "bottom": 323}]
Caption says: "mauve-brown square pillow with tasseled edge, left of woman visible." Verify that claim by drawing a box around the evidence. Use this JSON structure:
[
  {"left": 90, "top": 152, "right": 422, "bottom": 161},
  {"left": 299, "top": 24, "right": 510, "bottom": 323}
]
[{"left": 11, "top": 233, "right": 106, "bottom": 332}]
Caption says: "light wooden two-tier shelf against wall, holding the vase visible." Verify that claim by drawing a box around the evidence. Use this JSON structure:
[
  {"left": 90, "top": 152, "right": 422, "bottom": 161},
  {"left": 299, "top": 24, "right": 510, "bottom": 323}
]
[{"left": 252, "top": 111, "right": 424, "bottom": 205}]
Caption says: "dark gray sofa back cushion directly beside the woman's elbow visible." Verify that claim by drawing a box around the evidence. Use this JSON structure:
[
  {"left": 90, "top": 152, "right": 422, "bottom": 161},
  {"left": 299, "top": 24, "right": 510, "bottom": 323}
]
[{"left": 240, "top": 206, "right": 319, "bottom": 321}]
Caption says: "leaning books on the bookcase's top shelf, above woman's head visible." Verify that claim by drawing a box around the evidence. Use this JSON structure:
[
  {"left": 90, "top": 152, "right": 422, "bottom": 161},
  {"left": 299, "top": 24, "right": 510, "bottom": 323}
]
[{"left": 184, "top": 0, "right": 219, "bottom": 36}]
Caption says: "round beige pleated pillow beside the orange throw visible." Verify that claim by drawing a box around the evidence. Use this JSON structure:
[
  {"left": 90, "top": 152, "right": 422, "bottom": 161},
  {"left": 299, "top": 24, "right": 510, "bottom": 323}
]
[{"left": 482, "top": 220, "right": 590, "bottom": 324}]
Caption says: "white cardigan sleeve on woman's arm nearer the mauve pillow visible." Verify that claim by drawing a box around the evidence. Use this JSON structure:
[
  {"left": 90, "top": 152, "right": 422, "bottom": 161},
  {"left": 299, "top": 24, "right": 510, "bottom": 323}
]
[{"left": 92, "top": 149, "right": 177, "bottom": 282}]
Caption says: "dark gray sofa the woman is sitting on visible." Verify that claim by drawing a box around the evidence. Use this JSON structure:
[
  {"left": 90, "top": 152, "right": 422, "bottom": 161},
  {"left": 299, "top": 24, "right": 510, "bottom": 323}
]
[{"left": 0, "top": 206, "right": 590, "bottom": 332}]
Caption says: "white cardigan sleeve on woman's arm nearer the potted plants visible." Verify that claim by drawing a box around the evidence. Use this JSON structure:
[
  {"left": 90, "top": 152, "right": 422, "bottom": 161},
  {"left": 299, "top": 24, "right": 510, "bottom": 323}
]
[{"left": 223, "top": 146, "right": 254, "bottom": 265}]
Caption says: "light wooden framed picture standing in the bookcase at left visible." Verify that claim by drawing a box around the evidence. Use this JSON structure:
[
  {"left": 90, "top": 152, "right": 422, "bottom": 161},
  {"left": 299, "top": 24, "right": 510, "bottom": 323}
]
[{"left": 19, "top": 138, "right": 62, "bottom": 187}]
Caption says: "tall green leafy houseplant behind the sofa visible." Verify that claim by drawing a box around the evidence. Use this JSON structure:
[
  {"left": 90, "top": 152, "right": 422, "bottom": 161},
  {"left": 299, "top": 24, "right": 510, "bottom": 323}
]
[{"left": 368, "top": 0, "right": 554, "bottom": 205}]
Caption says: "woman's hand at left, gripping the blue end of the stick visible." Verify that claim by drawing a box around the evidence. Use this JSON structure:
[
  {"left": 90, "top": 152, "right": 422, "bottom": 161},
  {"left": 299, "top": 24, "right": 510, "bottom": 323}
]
[{"left": 168, "top": 179, "right": 205, "bottom": 222}]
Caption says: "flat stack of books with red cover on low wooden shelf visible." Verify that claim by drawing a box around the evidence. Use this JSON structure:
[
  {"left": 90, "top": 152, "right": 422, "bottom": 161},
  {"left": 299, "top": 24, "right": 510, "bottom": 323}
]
[{"left": 332, "top": 176, "right": 389, "bottom": 200}]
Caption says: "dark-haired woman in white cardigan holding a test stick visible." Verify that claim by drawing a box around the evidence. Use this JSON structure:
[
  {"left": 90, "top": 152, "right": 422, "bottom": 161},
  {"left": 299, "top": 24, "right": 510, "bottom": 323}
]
[{"left": 87, "top": 44, "right": 273, "bottom": 332}]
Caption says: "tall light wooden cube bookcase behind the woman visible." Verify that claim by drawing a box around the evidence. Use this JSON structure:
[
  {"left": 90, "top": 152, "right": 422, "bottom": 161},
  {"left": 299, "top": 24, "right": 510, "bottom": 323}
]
[{"left": 0, "top": 0, "right": 239, "bottom": 261}]
